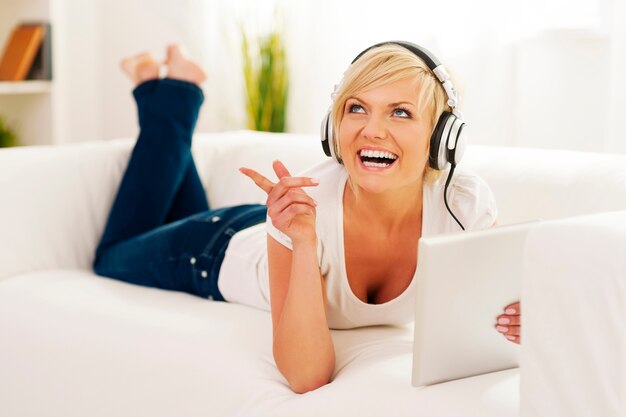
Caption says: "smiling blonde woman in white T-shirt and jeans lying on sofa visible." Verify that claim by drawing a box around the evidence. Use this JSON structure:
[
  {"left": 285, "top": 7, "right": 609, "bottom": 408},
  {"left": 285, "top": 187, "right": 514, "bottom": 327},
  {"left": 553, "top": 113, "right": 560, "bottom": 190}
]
[{"left": 94, "top": 43, "right": 520, "bottom": 393}]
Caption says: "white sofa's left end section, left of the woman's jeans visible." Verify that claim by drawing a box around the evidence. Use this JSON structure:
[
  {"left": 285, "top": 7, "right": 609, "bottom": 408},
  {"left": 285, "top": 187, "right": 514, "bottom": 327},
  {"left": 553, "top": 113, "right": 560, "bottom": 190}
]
[{"left": 0, "top": 141, "right": 131, "bottom": 280}]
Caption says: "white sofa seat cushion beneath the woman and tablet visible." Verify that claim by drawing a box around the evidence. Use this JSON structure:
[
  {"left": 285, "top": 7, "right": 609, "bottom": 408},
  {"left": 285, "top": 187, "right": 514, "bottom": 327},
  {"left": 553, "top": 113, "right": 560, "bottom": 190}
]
[{"left": 0, "top": 270, "right": 519, "bottom": 417}]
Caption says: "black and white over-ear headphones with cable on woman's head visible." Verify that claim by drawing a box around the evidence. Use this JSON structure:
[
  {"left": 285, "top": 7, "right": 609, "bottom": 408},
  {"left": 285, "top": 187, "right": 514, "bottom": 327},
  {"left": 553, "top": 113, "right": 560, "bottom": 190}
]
[{"left": 321, "top": 41, "right": 467, "bottom": 230}]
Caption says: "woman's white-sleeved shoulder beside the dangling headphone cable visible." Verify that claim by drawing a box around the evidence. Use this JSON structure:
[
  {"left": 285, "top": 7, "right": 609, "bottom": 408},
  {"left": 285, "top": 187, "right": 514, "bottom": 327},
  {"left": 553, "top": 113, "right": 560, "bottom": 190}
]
[{"left": 431, "top": 169, "right": 498, "bottom": 230}]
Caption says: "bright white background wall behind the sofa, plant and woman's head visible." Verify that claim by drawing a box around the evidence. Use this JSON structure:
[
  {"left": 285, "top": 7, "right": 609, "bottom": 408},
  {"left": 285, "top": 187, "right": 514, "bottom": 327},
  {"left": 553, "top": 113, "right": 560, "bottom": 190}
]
[{"left": 56, "top": 0, "right": 626, "bottom": 152}]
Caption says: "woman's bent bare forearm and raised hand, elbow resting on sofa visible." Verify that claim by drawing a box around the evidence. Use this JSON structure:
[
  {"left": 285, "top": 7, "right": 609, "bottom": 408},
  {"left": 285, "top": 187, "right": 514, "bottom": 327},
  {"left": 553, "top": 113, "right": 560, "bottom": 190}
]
[{"left": 241, "top": 161, "right": 335, "bottom": 393}]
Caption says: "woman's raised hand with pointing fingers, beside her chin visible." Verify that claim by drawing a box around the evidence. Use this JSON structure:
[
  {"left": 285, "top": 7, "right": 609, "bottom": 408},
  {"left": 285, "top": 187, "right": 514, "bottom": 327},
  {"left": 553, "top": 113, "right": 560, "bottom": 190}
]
[{"left": 239, "top": 161, "right": 319, "bottom": 243}]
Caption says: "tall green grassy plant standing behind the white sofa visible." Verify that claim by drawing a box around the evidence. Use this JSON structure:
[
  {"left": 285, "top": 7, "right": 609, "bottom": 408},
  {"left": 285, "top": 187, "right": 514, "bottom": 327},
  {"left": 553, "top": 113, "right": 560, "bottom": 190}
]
[{"left": 241, "top": 23, "right": 289, "bottom": 132}]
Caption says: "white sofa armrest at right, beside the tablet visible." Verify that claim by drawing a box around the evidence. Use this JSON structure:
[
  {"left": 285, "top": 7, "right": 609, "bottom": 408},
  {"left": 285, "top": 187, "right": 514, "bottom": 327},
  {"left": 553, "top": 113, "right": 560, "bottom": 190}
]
[{"left": 520, "top": 211, "right": 626, "bottom": 417}]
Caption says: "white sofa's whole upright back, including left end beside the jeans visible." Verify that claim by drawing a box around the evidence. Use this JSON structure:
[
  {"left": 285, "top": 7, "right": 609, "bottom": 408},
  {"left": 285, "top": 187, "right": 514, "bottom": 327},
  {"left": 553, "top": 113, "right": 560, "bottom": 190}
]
[{"left": 0, "top": 131, "right": 626, "bottom": 279}]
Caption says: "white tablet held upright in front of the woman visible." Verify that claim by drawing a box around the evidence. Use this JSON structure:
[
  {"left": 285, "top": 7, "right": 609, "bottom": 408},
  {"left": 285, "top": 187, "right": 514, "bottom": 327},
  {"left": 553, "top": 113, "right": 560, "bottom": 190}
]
[{"left": 412, "top": 222, "right": 537, "bottom": 386}]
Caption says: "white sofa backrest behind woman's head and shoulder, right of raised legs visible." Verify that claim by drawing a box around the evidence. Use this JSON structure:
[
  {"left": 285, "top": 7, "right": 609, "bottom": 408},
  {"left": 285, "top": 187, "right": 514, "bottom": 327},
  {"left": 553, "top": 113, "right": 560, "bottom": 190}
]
[{"left": 196, "top": 131, "right": 626, "bottom": 224}]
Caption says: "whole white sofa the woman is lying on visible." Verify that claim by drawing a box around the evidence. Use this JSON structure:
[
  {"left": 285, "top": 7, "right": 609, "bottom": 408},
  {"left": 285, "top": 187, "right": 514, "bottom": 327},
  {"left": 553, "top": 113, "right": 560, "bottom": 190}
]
[{"left": 0, "top": 131, "right": 626, "bottom": 417}]
